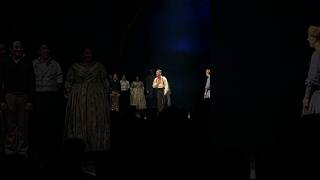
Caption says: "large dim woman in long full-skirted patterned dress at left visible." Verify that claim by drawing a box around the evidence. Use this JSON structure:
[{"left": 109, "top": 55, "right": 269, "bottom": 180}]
[{"left": 64, "top": 48, "right": 110, "bottom": 151}]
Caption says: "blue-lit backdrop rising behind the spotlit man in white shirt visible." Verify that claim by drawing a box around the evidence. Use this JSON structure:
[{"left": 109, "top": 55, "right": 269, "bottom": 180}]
[{"left": 151, "top": 0, "right": 211, "bottom": 107}]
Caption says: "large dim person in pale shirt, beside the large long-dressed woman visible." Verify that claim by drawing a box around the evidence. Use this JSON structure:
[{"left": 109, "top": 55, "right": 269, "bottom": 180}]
[{"left": 32, "top": 42, "right": 63, "bottom": 163}]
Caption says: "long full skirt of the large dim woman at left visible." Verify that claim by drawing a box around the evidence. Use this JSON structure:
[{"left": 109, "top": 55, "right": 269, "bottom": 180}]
[{"left": 64, "top": 83, "right": 110, "bottom": 151}]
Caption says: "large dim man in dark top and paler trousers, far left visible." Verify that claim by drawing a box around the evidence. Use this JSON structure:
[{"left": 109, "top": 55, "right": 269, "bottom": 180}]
[{"left": 0, "top": 41, "right": 35, "bottom": 156}]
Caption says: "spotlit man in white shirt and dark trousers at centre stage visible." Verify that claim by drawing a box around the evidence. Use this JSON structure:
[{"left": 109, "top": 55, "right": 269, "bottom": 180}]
[{"left": 152, "top": 69, "right": 169, "bottom": 112}]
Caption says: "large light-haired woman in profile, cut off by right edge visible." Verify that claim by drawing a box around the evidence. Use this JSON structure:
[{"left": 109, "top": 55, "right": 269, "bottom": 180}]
[{"left": 299, "top": 26, "right": 320, "bottom": 177}]
